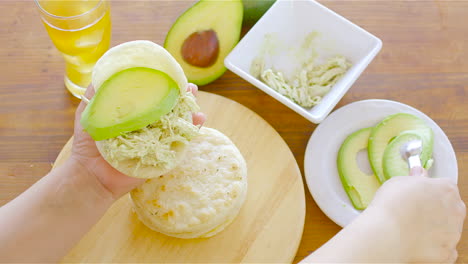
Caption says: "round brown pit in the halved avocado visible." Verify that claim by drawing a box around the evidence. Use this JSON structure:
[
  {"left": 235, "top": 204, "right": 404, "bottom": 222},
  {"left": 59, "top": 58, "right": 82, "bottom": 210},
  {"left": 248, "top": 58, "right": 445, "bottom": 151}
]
[{"left": 181, "top": 29, "right": 219, "bottom": 68}]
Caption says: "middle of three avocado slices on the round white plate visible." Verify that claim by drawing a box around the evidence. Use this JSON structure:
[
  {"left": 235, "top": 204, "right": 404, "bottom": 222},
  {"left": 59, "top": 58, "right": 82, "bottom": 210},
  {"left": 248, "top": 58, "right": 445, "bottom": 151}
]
[{"left": 368, "top": 113, "right": 434, "bottom": 183}]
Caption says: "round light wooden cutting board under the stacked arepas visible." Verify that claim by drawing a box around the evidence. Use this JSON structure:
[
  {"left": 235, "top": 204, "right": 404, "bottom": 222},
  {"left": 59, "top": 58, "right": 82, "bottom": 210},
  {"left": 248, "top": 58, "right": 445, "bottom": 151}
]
[{"left": 54, "top": 92, "right": 305, "bottom": 263}]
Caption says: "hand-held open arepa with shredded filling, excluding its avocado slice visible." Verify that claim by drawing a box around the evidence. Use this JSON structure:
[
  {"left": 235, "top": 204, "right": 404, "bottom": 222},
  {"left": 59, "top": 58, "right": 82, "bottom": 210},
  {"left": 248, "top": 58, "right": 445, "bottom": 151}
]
[{"left": 92, "top": 40, "right": 199, "bottom": 178}]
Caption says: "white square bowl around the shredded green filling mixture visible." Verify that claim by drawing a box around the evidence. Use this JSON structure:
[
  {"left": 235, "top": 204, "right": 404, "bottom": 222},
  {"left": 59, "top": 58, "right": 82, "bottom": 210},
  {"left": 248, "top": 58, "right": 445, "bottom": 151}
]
[{"left": 224, "top": 0, "right": 382, "bottom": 123}]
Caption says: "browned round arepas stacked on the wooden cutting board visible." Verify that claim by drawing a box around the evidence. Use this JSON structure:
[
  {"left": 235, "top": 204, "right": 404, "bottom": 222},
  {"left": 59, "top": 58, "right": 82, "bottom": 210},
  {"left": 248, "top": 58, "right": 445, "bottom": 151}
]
[{"left": 130, "top": 127, "right": 247, "bottom": 238}]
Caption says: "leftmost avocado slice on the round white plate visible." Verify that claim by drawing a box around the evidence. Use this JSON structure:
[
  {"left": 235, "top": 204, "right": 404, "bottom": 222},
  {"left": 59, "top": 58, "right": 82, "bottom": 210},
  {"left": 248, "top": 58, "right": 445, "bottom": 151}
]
[{"left": 337, "top": 127, "right": 380, "bottom": 210}]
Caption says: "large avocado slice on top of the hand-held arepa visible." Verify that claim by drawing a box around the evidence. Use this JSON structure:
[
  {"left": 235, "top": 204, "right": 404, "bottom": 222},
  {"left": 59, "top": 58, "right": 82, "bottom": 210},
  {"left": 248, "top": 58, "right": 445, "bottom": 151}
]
[{"left": 80, "top": 67, "right": 179, "bottom": 141}]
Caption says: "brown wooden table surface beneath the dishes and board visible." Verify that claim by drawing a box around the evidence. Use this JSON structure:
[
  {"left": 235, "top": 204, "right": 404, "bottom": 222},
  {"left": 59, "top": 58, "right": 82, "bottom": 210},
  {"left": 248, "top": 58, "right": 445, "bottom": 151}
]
[{"left": 0, "top": 0, "right": 468, "bottom": 263}]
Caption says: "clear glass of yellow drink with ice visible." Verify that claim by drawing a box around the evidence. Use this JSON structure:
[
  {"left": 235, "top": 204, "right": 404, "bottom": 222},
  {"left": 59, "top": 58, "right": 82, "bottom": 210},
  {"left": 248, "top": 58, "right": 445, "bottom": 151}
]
[{"left": 35, "top": 0, "right": 111, "bottom": 98}]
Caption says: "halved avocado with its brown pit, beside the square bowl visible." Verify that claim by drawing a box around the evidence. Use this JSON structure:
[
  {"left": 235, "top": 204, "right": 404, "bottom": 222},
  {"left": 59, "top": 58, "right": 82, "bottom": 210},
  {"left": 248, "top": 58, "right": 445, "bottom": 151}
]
[{"left": 164, "top": 0, "right": 243, "bottom": 85}]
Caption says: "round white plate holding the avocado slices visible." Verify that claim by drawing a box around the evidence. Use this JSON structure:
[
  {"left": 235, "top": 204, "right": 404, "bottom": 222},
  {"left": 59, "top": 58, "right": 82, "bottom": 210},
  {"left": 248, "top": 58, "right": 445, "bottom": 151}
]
[{"left": 304, "top": 100, "right": 458, "bottom": 227}]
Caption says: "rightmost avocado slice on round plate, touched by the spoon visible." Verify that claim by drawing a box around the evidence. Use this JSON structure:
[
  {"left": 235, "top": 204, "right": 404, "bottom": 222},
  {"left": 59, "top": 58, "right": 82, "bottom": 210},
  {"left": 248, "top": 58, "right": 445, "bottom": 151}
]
[{"left": 382, "top": 131, "right": 426, "bottom": 179}]
